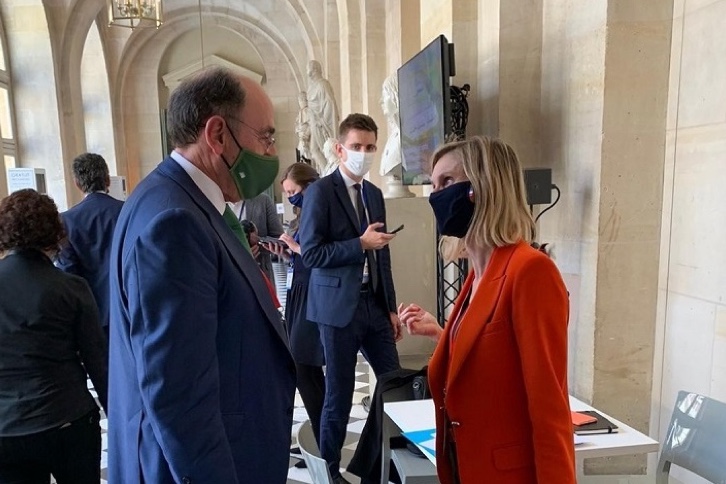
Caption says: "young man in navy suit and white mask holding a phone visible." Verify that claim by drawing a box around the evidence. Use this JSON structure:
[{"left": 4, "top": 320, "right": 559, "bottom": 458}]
[{"left": 299, "top": 114, "right": 402, "bottom": 483}]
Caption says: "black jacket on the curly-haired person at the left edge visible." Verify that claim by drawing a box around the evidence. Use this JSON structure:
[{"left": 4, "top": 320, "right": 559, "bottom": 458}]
[{"left": 0, "top": 250, "right": 108, "bottom": 437}]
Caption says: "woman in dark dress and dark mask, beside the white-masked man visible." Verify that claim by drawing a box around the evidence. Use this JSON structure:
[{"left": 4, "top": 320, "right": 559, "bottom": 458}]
[{"left": 264, "top": 163, "right": 325, "bottom": 445}]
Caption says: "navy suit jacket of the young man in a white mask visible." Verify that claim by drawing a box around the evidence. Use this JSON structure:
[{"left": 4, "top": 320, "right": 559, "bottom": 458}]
[{"left": 299, "top": 170, "right": 396, "bottom": 328}]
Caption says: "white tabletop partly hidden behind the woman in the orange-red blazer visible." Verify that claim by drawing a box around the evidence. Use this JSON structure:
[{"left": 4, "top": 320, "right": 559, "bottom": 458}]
[{"left": 384, "top": 395, "right": 658, "bottom": 472}]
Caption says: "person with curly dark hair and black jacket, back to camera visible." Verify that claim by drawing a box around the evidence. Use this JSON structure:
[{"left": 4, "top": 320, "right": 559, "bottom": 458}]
[{"left": 0, "top": 189, "right": 108, "bottom": 484}]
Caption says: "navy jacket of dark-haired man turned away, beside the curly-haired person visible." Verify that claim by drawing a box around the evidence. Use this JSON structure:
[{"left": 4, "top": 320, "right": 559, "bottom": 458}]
[{"left": 56, "top": 193, "right": 123, "bottom": 327}]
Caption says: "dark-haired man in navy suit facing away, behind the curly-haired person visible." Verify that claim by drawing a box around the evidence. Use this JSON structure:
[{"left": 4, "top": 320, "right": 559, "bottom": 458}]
[{"left": 56, "top": 153, "right": 123, "bottom": 340}]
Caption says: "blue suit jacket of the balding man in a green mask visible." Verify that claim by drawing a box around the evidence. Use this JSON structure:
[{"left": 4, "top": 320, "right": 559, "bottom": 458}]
[{"left": 108, "top": 158, "right": 295, "bottom": 484}]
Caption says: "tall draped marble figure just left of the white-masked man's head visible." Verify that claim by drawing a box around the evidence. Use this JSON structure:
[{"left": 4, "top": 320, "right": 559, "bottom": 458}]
[{"left": 307, "top": 60, "right": 340, "bottom": 171}]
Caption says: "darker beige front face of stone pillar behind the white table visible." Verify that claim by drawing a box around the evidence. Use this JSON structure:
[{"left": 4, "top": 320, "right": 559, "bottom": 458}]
[{"left": 586, "top": 0, "right": 673, "bottom": 473}]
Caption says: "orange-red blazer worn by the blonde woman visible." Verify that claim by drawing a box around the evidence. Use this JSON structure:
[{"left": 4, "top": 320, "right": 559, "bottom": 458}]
[{"left": 429, "top": 242, "right": 576, "bottom": 484}]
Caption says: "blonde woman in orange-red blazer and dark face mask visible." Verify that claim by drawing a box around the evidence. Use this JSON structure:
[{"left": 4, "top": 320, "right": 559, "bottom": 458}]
[{"left": 401, "top": 137, "right": 576, "bottom": 484}]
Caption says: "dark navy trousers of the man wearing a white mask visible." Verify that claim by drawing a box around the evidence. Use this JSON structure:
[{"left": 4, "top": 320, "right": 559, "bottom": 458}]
[{"left": 318, "top": 291, "right": 401, "bottom": 478}]
